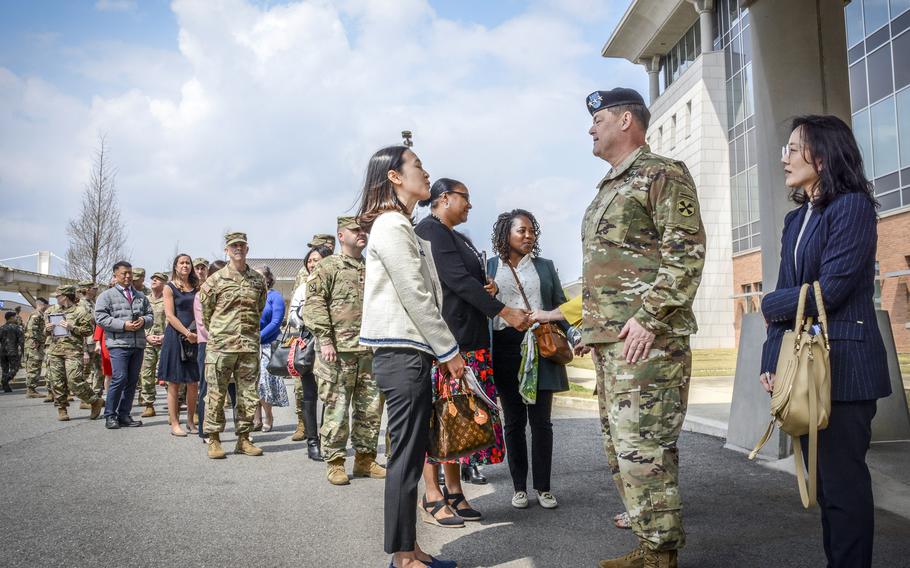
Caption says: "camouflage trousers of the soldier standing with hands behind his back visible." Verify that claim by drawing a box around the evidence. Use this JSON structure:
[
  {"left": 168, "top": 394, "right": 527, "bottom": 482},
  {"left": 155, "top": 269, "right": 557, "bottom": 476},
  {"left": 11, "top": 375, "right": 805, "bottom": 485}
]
[{"left": 202, "top": 348, "right": 260, "bottom": 434}]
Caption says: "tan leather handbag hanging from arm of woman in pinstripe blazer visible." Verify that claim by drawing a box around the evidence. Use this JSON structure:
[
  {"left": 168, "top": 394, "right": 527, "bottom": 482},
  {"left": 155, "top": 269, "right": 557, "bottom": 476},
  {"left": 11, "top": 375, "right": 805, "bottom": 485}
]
[{"left": 749, "top": 282, "right": 831, "bottom": 509}]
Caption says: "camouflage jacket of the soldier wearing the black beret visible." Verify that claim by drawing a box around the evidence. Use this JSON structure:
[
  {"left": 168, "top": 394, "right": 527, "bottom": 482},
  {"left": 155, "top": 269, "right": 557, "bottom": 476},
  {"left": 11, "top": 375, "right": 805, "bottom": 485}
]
[{"left": 581, "top": 145, "right": 705, "bottom": 344}]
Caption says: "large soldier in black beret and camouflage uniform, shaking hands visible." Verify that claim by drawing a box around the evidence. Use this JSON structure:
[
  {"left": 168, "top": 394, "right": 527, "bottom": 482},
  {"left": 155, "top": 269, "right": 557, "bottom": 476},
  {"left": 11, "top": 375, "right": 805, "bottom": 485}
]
[{"left": 582, "top": 88, "right": 705, "bottom": 568}]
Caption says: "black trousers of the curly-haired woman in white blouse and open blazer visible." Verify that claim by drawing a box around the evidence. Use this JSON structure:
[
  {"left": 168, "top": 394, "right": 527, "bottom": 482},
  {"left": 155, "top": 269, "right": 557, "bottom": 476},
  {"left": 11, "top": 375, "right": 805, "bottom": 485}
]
[{"left": 493, "top": 330, "right": 553, "bottom": 492}]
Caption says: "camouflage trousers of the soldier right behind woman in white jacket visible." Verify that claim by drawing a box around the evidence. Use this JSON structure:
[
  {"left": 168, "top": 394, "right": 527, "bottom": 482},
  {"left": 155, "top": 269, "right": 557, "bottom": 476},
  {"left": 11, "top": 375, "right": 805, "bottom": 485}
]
[{"left": 315, "top": 352, "right": 382, "bottom": 461}]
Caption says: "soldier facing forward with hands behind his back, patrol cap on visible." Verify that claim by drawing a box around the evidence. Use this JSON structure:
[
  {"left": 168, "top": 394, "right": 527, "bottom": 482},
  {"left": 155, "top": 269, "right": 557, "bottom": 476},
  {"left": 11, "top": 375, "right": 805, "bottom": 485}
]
[{"left": 199, "top": 233, "right": 268, "bottom": 459}]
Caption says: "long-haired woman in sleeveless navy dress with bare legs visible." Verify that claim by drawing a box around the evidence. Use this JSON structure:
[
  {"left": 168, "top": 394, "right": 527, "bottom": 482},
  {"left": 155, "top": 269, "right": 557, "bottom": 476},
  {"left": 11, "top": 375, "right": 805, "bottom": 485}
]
[{"left": 158, "top": 254, "right": 199, "bottom": 437}]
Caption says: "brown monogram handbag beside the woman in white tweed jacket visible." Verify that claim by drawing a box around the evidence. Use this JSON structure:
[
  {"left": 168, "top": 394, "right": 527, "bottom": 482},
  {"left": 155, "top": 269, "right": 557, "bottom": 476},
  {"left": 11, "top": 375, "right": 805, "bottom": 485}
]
[{"left": 427, "top": 377, "right": 496, "bottom": 461}]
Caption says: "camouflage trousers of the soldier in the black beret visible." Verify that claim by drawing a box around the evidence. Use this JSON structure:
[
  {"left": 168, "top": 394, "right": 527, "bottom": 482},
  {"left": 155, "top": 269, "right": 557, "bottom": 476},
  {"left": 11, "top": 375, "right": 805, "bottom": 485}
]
[{"left": 592, "top": 336, "right": 692, "bottom": 550}]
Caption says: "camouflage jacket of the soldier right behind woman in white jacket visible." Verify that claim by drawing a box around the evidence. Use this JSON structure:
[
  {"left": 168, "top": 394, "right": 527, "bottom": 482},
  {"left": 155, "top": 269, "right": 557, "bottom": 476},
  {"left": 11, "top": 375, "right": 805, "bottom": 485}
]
[{"left": 303, "top": 254, "right": 369, "bottom": 352}]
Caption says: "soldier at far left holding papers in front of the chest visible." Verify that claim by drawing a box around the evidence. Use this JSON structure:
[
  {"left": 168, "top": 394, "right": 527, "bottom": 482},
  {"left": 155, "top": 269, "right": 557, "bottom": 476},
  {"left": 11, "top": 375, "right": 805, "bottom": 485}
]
[{"left": 44, "top": 286, "right": 104, "bottom": 421}]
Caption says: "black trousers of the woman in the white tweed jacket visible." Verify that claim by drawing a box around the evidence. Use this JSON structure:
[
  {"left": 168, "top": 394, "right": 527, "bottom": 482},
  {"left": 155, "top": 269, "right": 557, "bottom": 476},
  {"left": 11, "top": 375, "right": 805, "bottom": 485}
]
[{"left": 373, "top": 348, "right": 433, "bottom": 554}]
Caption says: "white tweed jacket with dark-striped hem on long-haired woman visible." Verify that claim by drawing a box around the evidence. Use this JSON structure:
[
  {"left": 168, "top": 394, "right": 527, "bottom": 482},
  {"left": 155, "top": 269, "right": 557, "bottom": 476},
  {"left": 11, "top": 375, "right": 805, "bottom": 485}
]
[{"left": 360, "top": 212, "right": 458, "bottom": 362}]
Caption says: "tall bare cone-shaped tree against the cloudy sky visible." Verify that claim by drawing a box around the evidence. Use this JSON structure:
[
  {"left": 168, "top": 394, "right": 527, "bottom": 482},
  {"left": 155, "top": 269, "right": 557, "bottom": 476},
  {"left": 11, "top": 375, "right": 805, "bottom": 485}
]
[{"left": 66, "top": 135, "right": 126, "bottom": 282}]
